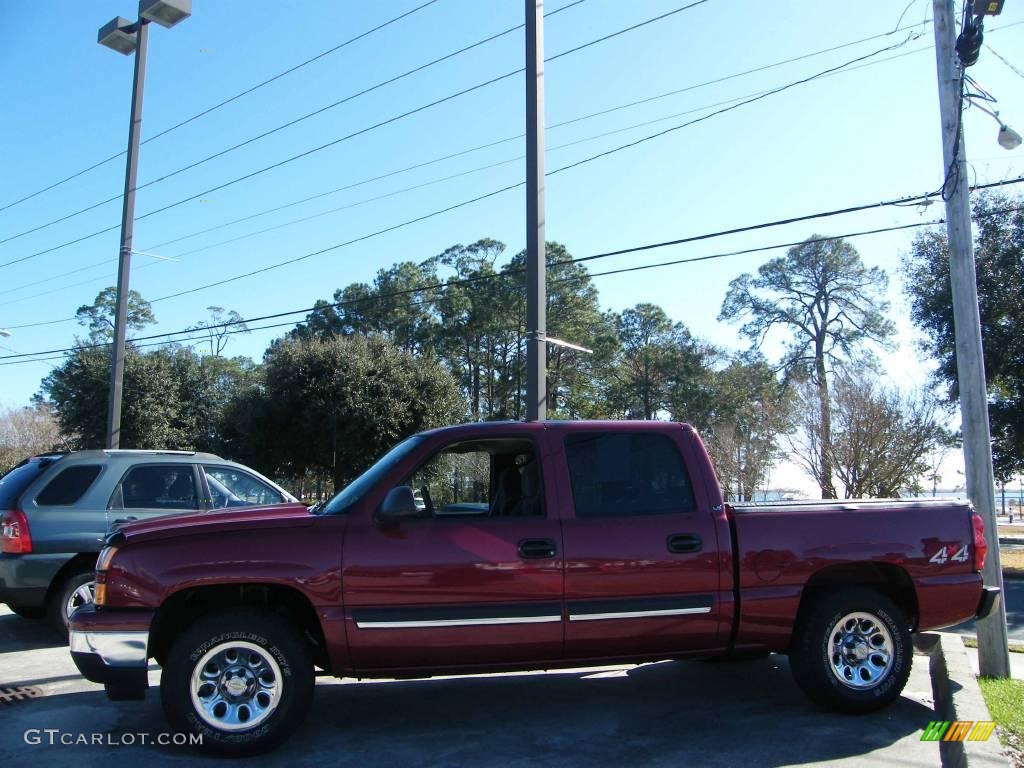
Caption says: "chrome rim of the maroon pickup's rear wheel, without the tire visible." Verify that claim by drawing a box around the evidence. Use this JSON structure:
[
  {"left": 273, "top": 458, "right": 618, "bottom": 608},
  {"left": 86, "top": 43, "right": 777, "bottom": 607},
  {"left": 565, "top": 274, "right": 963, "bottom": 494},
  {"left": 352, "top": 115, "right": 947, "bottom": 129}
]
[{"left": 827, "top": 612, "right": 894, "bottom": 690}]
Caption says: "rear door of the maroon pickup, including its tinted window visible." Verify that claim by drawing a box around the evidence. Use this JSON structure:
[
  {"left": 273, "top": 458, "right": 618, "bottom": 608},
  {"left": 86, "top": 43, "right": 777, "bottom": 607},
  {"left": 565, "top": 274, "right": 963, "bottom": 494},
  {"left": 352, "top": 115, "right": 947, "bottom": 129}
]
[{"left": 560, "top": 424, "right": 731, "bottom": 658}]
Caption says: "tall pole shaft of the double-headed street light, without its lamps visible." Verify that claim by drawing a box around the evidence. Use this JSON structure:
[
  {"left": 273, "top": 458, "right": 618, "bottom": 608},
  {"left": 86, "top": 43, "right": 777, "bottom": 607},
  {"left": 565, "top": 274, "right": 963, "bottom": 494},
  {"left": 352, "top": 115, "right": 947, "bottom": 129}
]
[{"left": 106, "top": 17, "right": 150, "bottom": 449}]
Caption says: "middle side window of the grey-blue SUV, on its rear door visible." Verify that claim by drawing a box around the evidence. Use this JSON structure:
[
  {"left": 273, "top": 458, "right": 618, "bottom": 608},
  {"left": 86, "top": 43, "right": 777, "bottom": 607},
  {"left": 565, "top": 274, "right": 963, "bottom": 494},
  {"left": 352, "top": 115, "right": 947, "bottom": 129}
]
[{"left": 110, "top": 462, "right": 202, "bottom": 520}]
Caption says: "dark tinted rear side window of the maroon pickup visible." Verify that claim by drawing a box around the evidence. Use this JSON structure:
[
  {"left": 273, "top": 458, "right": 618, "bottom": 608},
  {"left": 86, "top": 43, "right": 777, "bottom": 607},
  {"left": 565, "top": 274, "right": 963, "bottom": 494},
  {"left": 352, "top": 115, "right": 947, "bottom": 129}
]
[{"left": 565, "top": 432, "right": 695, "bottom": 517}]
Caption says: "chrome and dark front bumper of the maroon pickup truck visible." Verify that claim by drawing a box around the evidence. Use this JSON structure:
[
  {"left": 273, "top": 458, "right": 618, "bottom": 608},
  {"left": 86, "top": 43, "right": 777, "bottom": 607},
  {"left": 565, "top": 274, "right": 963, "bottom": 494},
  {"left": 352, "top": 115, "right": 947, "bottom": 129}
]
[{"left": 70, "top": 605, "right": 153, "bottom": 698}]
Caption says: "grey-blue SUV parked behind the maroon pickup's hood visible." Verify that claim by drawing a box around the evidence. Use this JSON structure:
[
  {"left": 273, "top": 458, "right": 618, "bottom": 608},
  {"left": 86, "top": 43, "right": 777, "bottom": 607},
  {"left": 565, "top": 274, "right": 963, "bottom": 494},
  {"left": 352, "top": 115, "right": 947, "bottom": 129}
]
[{"left": 0, "top": 451, "right": 296, "bottom": 632}]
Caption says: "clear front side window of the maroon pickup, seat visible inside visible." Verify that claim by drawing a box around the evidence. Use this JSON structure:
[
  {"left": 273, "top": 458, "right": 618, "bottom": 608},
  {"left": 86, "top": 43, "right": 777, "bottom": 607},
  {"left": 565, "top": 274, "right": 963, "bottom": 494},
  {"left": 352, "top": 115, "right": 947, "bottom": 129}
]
[{"left": 406, "top": 439, "right": 544, "bottom": 517}]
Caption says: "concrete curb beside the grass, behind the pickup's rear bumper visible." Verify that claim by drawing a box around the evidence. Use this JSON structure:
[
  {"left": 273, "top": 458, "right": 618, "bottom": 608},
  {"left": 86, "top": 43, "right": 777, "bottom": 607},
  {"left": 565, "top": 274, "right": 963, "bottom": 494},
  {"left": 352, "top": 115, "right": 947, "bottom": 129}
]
[{"left": 914, "top": 632, "right": 1010, "bottom": 768}]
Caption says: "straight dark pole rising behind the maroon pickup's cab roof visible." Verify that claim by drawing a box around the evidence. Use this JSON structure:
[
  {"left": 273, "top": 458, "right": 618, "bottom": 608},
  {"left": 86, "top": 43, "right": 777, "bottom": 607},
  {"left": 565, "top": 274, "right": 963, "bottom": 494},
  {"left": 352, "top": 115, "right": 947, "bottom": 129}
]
[{"left": 525, "top": 0, "right": 548, "bottom": 421}]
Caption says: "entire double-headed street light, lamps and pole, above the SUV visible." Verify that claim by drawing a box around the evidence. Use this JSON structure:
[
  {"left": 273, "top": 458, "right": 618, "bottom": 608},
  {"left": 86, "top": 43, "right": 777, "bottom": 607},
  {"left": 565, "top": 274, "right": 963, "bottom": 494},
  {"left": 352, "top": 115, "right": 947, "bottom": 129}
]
[{"left": 97, "top": 0, "right": 191, "bottom": 449}]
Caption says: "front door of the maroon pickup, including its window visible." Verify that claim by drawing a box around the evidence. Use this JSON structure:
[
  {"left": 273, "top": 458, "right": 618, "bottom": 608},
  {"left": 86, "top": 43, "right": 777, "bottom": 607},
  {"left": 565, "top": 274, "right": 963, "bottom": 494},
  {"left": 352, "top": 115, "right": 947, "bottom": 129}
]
[{"left": 342, "top": 428, "right": 562, "bottom": 670}]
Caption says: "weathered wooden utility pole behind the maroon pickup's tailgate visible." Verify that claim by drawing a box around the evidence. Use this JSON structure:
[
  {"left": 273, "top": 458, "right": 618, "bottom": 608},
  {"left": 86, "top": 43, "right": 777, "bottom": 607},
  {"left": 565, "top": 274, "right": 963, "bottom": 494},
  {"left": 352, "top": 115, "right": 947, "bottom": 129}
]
[{"left": 932, "top": 0, "right": 1010, "bottom": 678}]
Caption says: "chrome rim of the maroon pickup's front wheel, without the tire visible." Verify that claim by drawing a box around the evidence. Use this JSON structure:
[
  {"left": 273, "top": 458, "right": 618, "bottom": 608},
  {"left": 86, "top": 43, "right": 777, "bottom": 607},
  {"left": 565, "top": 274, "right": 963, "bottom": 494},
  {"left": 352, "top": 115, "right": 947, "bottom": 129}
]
[{"left": 189, "top": 640, "right": 283, "bottom": 731}]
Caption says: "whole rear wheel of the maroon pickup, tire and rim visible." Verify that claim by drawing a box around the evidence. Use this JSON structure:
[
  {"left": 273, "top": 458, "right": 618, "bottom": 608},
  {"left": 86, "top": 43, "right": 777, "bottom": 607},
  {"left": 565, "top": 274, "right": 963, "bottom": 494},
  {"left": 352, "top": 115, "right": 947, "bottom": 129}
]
[{"left": 790, "top": 589, "right": 912, "bottom": 714}]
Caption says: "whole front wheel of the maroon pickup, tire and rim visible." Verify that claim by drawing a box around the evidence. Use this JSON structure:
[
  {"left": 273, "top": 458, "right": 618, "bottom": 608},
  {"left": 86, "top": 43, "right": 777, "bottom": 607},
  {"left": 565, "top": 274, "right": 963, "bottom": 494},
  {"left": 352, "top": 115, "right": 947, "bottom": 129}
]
[{"left": 160, "top": 609, "right": 313, "bottom": 757}]
